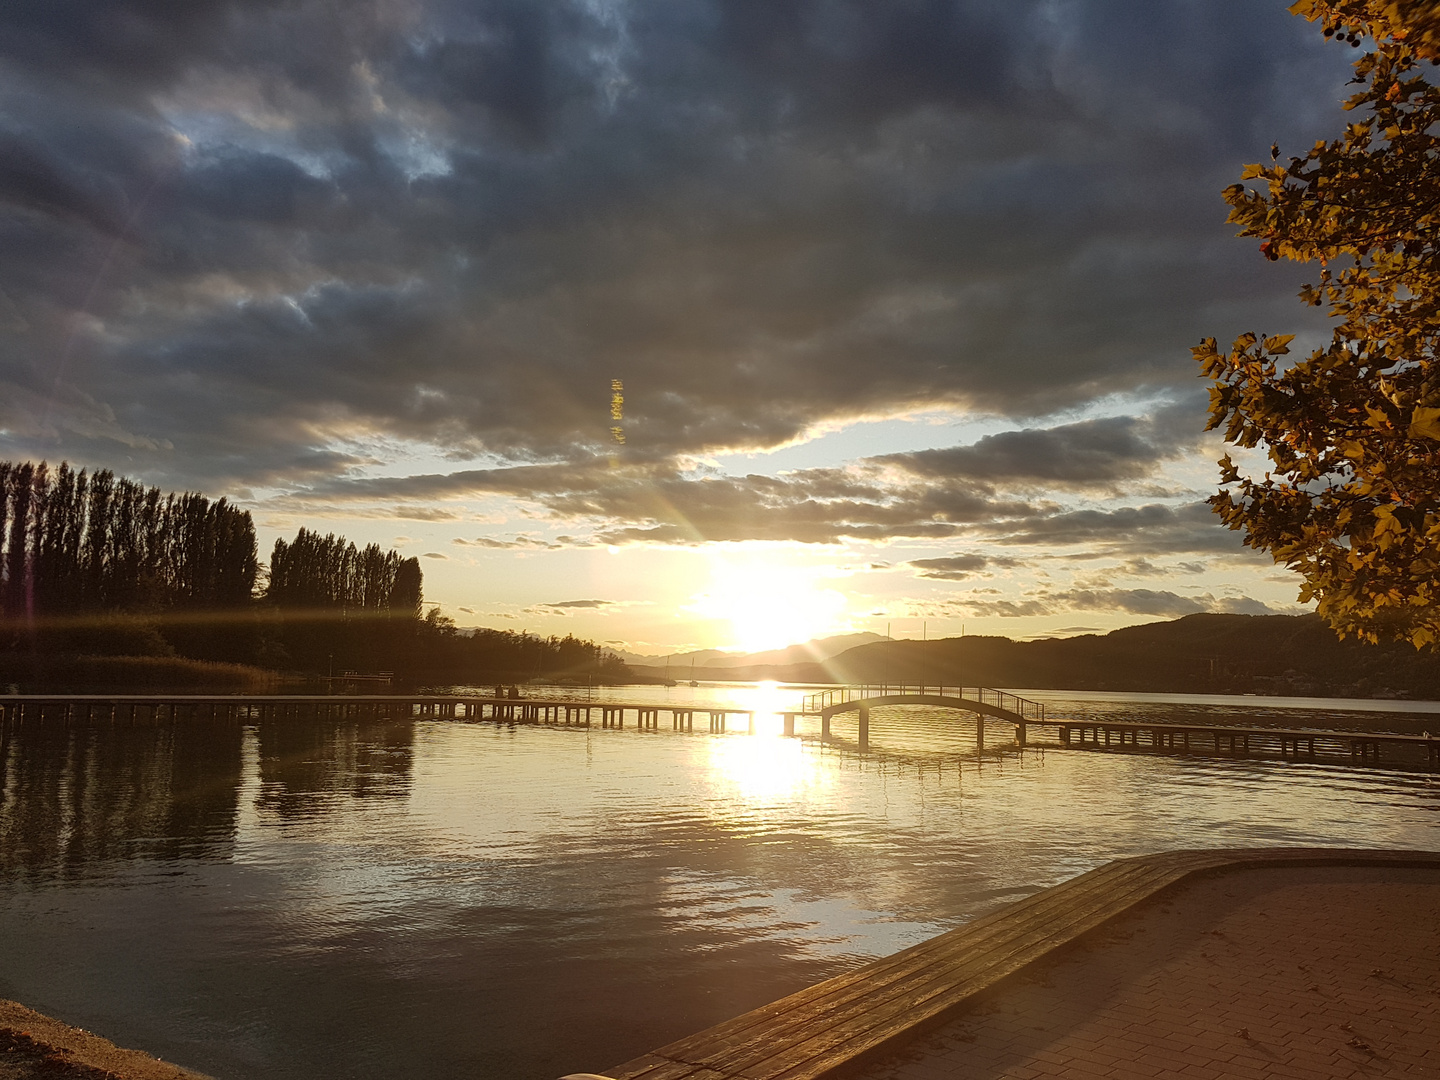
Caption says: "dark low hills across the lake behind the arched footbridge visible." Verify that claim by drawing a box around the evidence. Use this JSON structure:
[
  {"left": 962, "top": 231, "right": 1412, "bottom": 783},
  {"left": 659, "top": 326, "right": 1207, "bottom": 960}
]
[{"left": 632, "top": 613, "right": 1440, "bottom": 700}]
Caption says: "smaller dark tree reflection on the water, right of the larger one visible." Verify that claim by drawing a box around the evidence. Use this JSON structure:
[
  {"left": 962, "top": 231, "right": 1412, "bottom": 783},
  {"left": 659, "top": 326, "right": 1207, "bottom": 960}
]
[{"left": 258, "top": 717, "right": 415, "bottom": 819}]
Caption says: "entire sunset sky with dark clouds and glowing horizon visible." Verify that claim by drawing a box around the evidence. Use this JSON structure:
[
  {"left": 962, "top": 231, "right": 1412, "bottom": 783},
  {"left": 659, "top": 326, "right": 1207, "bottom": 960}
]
[{"left": 0, "top": 0, "right": 1356, "bottom": 654}]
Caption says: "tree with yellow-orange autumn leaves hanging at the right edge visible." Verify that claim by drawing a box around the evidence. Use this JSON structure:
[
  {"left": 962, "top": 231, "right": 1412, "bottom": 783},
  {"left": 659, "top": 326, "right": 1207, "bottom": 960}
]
[{"left": 1192, "top": 0, "right": 1440, "bottom": 648}]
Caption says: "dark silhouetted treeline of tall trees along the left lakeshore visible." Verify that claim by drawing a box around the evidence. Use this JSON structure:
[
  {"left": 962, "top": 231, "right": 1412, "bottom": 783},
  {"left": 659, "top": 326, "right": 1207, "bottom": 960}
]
[{"left": 0, "top": 462, "right": 625, "bottom": 684}]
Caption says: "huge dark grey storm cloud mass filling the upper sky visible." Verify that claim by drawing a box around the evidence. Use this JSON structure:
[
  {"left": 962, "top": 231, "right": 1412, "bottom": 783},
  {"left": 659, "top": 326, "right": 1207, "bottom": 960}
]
[{"left": 0, "top": 0, "right": 1351, "bottom": 495}]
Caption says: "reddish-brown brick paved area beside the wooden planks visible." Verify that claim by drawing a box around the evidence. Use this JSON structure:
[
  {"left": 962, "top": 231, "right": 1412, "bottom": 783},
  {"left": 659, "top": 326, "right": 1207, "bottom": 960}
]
[{"left": 858, "top": 867, "right": 1440, "bottom": 1080}]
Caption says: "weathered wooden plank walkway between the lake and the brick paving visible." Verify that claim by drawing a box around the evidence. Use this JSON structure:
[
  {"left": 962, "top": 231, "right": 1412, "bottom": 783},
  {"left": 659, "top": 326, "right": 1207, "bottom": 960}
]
[{"left": 578, "top": 848, "right": 1440, "bottom": 1080}]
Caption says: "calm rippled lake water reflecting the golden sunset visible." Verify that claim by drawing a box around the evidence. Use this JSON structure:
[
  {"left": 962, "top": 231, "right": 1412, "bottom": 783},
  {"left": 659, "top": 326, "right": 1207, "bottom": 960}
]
[{"left": 0, "top": 685, "right": 1440, "bottom": 1080}]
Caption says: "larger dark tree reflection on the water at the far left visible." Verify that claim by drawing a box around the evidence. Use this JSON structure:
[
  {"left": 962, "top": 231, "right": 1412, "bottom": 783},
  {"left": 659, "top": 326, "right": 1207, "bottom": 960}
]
[{"left": 0, "top": 724, "right": 242, "bottom": 877}]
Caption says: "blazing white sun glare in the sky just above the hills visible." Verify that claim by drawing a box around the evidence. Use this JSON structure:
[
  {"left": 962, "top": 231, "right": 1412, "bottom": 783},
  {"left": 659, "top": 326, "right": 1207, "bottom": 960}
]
[{"left": 690, "top": 553, "right": 845, "bottom": 652}]
